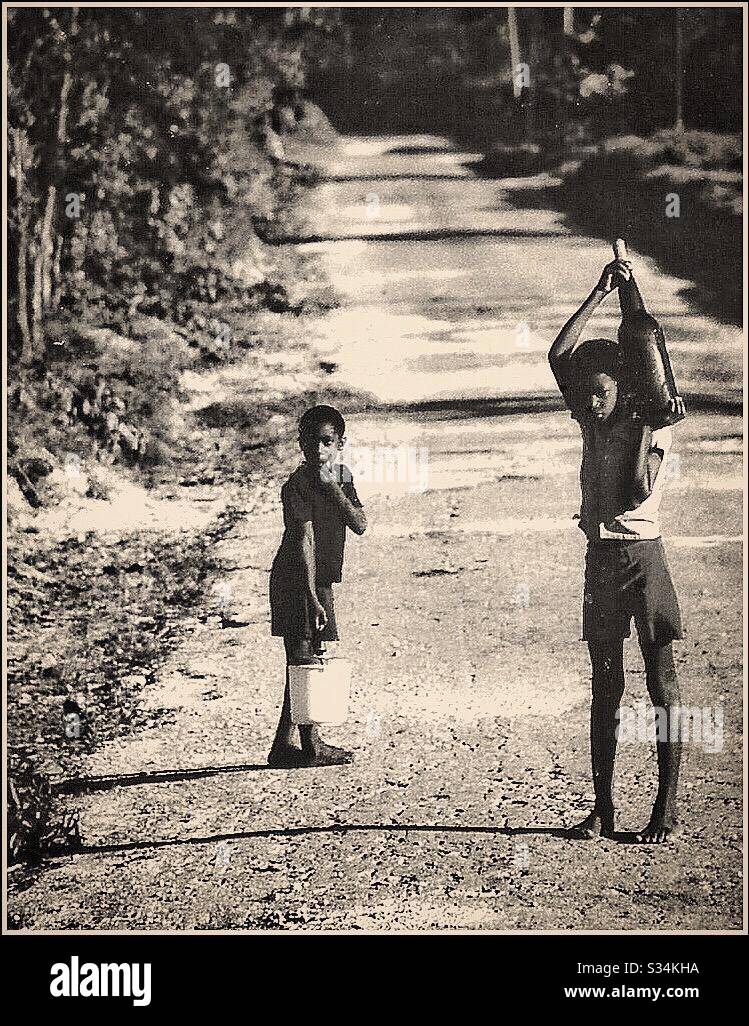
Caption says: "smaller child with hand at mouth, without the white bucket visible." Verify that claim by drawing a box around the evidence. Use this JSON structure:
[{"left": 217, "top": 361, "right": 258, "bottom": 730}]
[{"left": 268, "top": 405, "right": 366, "bottom": 768}]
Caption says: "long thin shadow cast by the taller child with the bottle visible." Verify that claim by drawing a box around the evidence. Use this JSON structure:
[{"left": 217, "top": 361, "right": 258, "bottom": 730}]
[{"left": 75, "top": 823, "right": 570, "bottom": 855}]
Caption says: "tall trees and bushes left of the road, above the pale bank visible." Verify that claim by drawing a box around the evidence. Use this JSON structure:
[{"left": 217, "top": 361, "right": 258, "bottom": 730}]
[{"left": 8, "top": 7, "right": 340, "bottom": 509}]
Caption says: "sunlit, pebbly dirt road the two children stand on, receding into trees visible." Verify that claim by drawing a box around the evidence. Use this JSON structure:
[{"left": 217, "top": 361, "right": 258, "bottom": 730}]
[{"left": 13, "top": 137, "right": 742, "bottom": 930}]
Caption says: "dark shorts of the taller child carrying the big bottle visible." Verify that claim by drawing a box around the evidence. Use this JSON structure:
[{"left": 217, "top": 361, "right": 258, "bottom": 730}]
[{"left": 583, "top": 538, "right": 684, "bottom": 645}]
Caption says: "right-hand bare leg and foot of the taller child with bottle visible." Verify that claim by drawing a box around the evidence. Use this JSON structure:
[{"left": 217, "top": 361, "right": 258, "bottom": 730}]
[{"left": 637, "top": 639, "right": 681, "bottom": 843}]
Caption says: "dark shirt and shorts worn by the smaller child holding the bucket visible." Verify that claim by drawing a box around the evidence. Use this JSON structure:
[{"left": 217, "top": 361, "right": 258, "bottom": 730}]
[{"left": 270, "top": 464, "right": 361, "bottom": 641}]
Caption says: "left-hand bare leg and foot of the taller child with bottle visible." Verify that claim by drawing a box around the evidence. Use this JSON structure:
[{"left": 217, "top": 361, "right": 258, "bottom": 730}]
[{"left": 571, "top": 638, "right": 624, "bottom": 838}]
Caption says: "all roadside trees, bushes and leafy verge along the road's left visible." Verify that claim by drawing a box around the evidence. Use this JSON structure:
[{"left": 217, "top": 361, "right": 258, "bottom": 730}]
[{"left": 7, "top": 7, "right": 334, "bottom": 863}]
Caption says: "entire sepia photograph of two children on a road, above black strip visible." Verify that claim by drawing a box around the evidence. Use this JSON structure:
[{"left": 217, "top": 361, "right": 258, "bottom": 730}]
[{"left": 3, "top": 3, "right": 746, "bottom": 948}]
